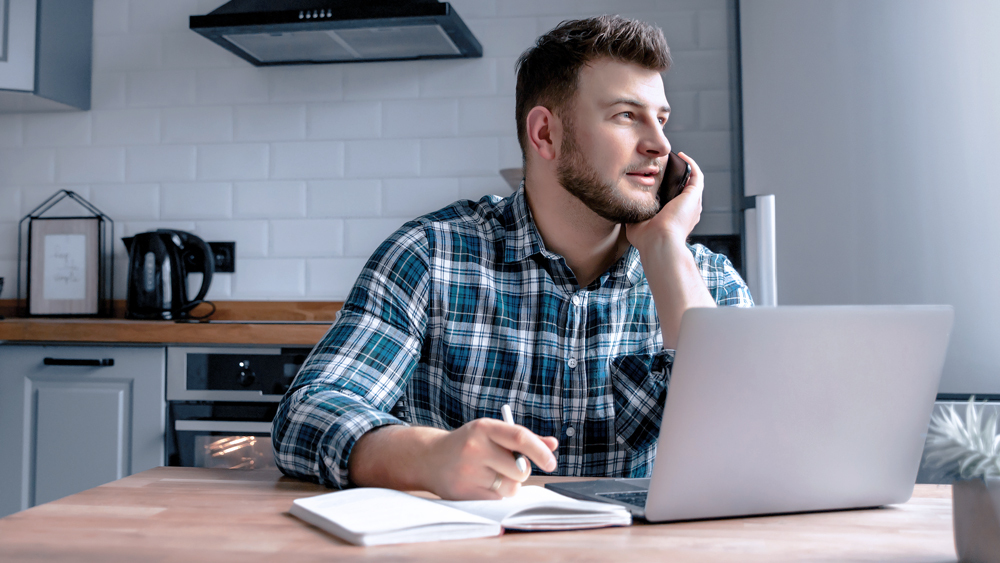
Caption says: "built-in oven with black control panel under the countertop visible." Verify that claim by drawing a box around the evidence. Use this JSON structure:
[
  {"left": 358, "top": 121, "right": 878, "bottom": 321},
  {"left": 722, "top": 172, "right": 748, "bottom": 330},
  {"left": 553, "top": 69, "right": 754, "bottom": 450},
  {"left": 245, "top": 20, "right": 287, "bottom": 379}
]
[{"left": 165, "top": 346, "right": 311, "bottom": 469}]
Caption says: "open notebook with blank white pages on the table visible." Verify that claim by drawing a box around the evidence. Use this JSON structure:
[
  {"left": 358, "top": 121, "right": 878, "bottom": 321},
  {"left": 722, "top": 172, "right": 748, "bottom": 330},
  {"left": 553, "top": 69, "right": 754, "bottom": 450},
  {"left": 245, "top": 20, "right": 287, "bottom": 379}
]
[{"left": 289, "top": 486, "right": 632, "bottom": 545}]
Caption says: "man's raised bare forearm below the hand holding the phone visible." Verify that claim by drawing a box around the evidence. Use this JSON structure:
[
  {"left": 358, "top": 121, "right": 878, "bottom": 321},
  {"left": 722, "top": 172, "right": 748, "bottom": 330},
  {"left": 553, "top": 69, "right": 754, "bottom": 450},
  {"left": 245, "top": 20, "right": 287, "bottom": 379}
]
[{"left": 640, "top": 237, "right": 716, "bottom": 349}]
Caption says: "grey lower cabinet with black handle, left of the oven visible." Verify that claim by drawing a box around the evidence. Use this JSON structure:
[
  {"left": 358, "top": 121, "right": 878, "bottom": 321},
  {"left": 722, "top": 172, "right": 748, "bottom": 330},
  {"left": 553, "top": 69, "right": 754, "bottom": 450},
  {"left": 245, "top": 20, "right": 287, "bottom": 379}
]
[{"left": 0, "top": 345, "right": 166, "bottom": 516}]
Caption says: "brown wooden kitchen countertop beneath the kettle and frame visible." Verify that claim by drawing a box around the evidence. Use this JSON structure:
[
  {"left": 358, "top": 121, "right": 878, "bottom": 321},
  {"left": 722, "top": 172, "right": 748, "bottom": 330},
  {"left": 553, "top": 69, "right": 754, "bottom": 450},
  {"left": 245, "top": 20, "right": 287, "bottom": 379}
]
[{"left": 0, "top": 301, "right": 341, "bottom": 346}]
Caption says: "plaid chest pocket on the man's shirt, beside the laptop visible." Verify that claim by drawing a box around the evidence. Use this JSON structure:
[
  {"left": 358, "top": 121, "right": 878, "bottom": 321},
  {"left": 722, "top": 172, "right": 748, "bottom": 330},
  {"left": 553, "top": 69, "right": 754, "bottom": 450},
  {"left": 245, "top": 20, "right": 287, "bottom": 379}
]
[{"left": 611, "top": 354, "right": 669, "bottom": 451}]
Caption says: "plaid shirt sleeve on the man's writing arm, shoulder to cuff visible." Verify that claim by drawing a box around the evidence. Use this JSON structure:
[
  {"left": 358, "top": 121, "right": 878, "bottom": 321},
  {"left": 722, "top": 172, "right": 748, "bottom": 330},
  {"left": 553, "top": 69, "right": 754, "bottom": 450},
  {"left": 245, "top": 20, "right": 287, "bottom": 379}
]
[{"left": 272, "top": 223, "right": 428, "bottom": 488}]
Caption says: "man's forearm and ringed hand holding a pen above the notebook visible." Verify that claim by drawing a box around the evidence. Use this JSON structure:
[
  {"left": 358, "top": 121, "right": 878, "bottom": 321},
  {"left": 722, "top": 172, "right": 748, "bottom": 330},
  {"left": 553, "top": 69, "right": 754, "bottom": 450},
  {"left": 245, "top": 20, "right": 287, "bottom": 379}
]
[{"left": 348, "top": 418, "right": 559, "bottom": 500}]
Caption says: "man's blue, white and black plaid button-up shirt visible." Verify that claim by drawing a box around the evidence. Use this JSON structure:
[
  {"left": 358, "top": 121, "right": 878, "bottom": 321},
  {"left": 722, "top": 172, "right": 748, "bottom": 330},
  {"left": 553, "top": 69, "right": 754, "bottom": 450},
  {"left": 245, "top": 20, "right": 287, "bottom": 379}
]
[{"left": 272, "top": 188, "right": 753, "bottom": 488}]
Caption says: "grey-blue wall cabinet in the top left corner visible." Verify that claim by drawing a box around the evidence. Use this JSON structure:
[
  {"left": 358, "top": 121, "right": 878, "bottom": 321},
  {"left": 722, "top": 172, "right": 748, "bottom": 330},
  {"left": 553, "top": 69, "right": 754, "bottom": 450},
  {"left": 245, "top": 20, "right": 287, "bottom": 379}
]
[{"left": 0, "top": 0, "right": 94, "bottom": 112}]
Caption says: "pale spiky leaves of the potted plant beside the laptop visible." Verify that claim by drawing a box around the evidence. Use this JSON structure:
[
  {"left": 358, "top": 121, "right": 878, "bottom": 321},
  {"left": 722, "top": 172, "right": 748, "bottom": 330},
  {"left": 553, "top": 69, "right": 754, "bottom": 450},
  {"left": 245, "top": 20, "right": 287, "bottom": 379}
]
[{"left": 927, "top": 396, "right": 1000, "bottom": 479}]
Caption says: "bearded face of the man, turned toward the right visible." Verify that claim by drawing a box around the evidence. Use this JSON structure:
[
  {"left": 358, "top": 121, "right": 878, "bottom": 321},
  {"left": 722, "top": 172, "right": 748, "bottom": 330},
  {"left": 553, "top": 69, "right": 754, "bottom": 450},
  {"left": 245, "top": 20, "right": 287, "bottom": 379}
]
[{"left": 557, "top": 59, "right": 670, "bottom": 223}]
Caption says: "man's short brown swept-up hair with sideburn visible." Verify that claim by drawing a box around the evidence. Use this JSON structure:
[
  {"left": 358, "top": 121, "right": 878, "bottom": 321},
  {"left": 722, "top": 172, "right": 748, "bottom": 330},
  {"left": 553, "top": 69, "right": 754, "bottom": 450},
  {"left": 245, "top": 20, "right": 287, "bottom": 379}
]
[{"left": 514, "top": 15, "right": 670, "bottom": 160}]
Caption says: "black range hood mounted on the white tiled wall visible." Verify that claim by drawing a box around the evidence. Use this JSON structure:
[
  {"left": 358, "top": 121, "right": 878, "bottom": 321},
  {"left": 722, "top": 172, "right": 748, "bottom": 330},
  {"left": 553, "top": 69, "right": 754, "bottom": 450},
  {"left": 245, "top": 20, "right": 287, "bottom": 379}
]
[{"left": 190, "top": 0, "right": 483, "bottom": 66}]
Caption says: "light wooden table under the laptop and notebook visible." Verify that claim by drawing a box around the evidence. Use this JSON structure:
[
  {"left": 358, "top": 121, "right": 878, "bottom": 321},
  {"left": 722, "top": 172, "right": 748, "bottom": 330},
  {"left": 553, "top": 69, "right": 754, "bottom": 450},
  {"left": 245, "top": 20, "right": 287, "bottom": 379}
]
[{"left": 0, "top": 468, "right": 955, "bottom": 563}]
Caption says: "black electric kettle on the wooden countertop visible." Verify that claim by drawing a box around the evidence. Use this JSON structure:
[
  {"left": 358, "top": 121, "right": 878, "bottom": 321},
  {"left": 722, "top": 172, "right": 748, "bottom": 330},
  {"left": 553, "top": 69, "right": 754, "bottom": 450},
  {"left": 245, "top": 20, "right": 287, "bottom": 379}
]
[{"left": 122, "top": 229, "right": 215, "bottom": 320}]
